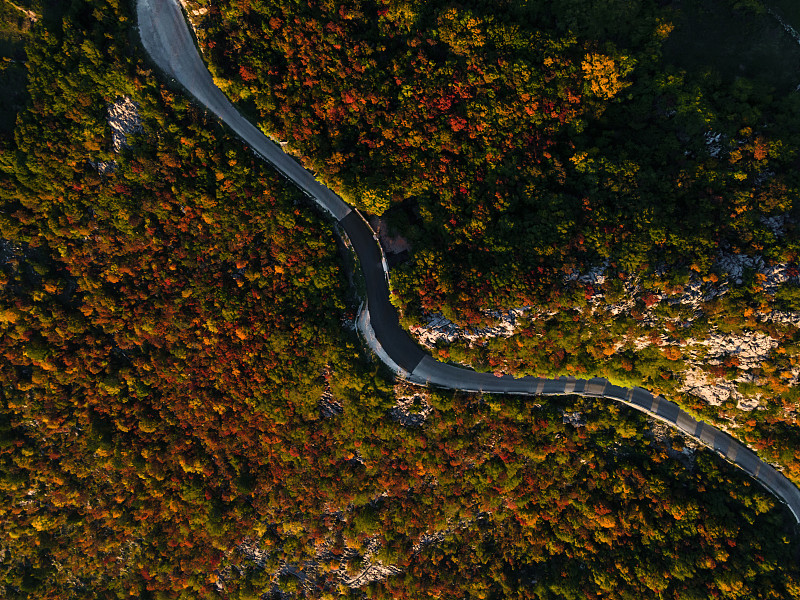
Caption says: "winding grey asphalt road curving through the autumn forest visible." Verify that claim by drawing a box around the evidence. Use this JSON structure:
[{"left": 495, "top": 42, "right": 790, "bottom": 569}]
[{"left": 137, "top": 0, "right": 800, "bottom": 523}]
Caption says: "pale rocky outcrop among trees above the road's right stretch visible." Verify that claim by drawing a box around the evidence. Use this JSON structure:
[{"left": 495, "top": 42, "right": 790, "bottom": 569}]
[{"left": 410, "top": 248, "right": 800, "bottom": 411}]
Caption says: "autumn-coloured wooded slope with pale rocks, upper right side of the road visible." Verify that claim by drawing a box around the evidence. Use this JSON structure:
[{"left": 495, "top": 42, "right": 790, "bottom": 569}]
[{"left": 198, "top": 0, "right": 800, "bottom": 483}]
